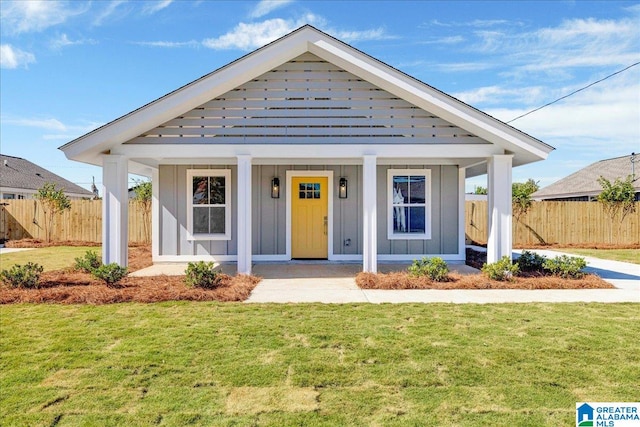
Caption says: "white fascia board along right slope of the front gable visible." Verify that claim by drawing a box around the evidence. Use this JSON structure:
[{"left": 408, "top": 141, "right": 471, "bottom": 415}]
[{"left": 309, "top": 40, "right": 553, "bottom": 160}]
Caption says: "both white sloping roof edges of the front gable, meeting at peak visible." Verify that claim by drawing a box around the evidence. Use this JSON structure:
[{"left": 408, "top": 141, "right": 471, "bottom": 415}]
[{"left": 60, "top": 25, "right": 553, "bottom": 172}]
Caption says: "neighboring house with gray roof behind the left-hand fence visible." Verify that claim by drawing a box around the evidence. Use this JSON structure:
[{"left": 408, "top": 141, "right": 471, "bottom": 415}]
[{"left": 0, "top": 154, "right": 94, "bottom": 200}]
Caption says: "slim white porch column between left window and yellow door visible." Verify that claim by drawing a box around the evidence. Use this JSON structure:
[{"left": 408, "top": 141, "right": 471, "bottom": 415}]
[{"left": 236, "top": 155, "right": 252, "bottom": 274}]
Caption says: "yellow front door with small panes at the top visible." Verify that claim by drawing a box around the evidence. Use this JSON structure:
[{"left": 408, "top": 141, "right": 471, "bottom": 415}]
[{"left": 291, "top": 176, "right": 329, "bottom": 258}]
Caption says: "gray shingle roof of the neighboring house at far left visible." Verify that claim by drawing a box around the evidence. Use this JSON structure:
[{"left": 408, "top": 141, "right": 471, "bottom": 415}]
[{"left": 0, "top": 154, "right": 93, "bottom": 197}]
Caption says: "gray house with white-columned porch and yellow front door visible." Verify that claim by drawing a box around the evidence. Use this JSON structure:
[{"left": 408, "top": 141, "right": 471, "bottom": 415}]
[{"left": 61, "top": 25, "right": 553, "bottom": 273}]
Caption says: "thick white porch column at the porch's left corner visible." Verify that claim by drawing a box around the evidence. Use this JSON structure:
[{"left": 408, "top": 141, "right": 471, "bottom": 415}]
[{"left": 102, "top": 154, "right": 129, "bottom": 267}]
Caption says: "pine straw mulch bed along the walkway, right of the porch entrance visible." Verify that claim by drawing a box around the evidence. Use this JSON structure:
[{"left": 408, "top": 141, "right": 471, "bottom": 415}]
[{"left": 356, "top": 272, "right": 615, "bottom": 289}]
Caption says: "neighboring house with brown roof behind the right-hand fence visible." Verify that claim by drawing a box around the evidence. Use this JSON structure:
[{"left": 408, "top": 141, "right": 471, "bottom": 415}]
[{"left": 531, "top": 153, "right": 640, "bottom": 202}]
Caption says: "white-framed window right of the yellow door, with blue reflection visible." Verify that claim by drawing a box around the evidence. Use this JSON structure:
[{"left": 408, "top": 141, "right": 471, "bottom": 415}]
[{"left": 387, "top": 169, "right": 431, "bottom": 239}]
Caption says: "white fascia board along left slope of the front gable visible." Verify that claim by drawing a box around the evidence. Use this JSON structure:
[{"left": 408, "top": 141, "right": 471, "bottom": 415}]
[{"left": 60, "top": 35, "right": 306, "bottom": 164}]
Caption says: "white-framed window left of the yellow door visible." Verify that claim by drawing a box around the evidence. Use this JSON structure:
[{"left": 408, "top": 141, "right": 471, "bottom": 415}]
[{"left": 187, "top": 169, "right": 231, "bottom": 240}]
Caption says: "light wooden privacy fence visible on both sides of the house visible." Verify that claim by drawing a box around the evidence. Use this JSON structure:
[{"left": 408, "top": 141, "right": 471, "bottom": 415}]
[{"left": 0, "top": 200, "right": 640, "bottom": 246}]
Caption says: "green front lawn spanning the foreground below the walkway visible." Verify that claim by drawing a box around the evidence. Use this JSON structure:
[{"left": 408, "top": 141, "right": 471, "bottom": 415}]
[{"left": 0, "top": 302, "right": 640, "bottom": 426}]
